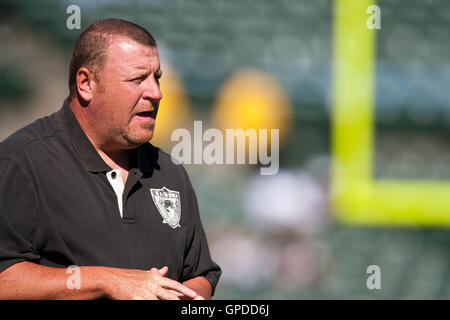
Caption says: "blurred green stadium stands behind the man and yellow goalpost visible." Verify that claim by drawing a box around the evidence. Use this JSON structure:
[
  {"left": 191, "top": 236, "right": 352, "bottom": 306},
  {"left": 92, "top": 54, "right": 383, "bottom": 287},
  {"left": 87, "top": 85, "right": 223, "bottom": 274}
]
[{"left": 0, "top": 0, "right": 450, "bottom": 299}]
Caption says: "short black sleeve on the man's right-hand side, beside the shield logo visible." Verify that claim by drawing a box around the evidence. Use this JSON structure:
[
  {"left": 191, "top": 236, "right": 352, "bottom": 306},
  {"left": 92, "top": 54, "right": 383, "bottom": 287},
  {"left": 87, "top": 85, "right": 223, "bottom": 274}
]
[{"left": 182, "top": 168, "right": 222, "bottom": 294}]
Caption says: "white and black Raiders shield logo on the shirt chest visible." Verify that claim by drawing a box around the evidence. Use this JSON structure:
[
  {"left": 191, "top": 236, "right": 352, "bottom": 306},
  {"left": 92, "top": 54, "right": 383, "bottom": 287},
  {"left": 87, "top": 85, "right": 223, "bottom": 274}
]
[{"left": 150, "top": 187, "right": 181, "bottom": 229}]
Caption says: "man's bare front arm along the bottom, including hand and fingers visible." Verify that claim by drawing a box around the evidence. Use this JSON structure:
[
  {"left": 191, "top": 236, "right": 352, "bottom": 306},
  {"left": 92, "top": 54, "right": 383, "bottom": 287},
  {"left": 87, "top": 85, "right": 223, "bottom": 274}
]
[{"left": 0, "top": 262, "right": 199, "bottom": 300}]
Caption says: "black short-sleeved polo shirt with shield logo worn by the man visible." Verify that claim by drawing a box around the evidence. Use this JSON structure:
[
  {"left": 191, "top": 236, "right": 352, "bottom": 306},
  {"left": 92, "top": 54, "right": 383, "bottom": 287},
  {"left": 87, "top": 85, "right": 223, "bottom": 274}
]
[{"left": 0, "top": 100, "right": 221, "bottom": 294}]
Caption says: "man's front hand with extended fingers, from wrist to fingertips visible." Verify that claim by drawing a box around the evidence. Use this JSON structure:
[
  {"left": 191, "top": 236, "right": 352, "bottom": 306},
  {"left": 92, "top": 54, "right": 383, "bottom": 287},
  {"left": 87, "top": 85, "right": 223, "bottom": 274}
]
[{"left": 105, "top": 267, "right": 201, "bottom": 300}]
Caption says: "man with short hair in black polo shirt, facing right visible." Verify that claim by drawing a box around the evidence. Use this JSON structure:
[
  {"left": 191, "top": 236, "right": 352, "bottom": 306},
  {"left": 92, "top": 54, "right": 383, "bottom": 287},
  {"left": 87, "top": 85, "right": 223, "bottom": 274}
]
[{"left": 0, "top": 19, "right": 221, "bottom": 300}]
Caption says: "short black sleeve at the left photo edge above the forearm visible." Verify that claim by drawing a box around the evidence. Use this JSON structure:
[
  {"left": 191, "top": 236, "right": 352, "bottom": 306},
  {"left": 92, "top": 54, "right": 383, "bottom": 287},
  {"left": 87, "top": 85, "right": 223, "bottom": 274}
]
[{"left": 0, "top": 158, "right": 39, "bottom": 272}]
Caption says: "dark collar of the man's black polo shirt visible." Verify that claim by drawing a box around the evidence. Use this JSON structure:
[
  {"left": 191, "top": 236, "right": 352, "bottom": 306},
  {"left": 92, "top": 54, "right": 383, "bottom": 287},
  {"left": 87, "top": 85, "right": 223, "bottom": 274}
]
[{"left": 56, "top": 98, "right": 159, "bottom": 173}]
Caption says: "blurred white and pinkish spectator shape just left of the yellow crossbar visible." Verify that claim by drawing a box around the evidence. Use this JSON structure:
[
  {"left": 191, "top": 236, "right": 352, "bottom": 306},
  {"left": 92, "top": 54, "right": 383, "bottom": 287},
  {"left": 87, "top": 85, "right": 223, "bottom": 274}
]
[{"left": 244, "top": 170, "right": 327, "bottom": 291}]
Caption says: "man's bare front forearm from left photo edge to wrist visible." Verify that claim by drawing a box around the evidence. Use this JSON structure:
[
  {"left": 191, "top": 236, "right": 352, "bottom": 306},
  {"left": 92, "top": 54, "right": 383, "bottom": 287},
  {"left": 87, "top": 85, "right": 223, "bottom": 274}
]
[{"left": 0, "top": 262, "right": 105, "bottom": 300}]
